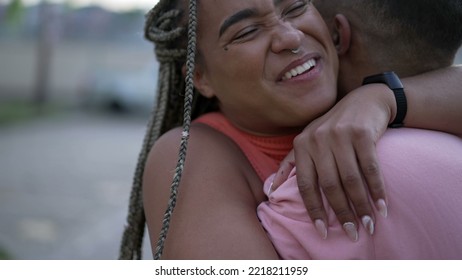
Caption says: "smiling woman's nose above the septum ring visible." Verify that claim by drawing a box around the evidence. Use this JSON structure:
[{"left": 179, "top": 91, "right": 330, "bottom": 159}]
[{"left": 271, "top": 21, "right": 303, "bottom": 53}]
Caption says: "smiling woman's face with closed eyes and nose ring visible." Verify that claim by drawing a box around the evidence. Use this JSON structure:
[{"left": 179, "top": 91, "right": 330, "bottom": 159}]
[{"left": 195, "top": 0, "right": 338, "bottom": 135}]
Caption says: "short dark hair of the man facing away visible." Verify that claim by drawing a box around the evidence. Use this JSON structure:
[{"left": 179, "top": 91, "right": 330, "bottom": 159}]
[{"left": 314, "top": 0, "right": 462, "bottom": 70}]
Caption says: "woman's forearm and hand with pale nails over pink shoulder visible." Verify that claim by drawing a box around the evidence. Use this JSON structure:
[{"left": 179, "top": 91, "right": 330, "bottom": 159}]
[{"left": 273, "top": 66, "right": 462, "bottom": 240}]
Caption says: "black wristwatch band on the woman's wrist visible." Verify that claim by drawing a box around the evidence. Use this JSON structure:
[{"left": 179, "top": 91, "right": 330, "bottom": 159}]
[{"left": 363, "top": 71, "right": 407, "bottom": 128}]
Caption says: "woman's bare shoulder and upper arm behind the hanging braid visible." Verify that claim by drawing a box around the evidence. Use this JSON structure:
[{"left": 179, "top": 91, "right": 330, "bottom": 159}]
[{"left": 143, "top": 125, "right": 278, "bottom": 259}]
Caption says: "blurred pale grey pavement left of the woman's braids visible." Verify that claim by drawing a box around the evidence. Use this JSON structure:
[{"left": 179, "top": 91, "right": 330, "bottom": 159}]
[{"left": 0, "top": 110, "right": 152, "bottom": 259}]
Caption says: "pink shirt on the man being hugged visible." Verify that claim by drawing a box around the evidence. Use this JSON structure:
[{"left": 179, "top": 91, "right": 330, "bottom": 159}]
[{"left": 258, "top": 128, "right": 462, "bottom": 259}]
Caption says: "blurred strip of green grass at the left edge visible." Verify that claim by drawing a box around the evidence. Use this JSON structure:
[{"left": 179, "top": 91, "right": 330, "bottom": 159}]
[{"left": 0, "top": 100, "right": 61, "bottom": 125}]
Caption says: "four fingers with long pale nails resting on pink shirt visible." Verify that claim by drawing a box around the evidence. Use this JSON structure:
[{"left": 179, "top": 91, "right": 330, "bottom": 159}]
[{"left": 295, "top": 129, "right": 386, "bottom": 241}]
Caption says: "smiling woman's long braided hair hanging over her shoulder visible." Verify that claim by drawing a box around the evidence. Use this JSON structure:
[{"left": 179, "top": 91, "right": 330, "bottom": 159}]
[{"left": 119, "top": 0, "right": 216, "bottom": 259}]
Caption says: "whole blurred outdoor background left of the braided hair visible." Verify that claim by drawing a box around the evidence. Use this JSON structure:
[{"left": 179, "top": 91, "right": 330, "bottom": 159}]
[{"left": 0, "top": 0, "right": 462, "bottom": 259}]
